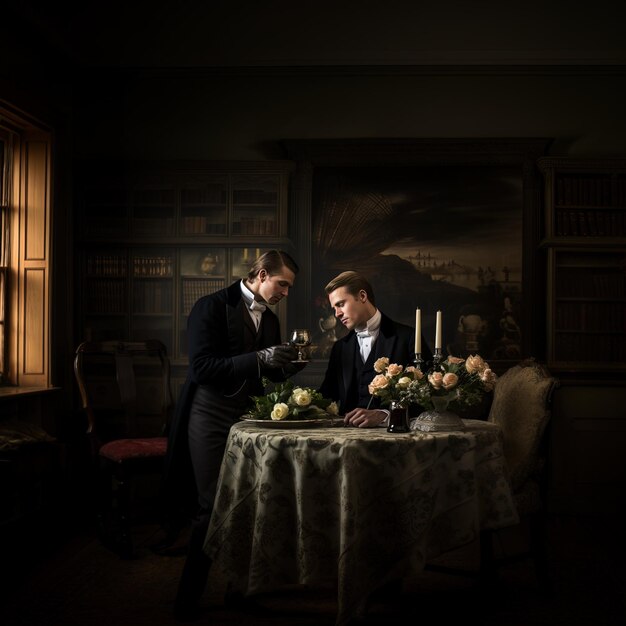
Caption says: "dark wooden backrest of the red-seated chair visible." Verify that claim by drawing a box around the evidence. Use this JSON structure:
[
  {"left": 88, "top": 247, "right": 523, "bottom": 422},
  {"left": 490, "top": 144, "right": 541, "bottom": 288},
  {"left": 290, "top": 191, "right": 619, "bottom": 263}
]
[{"left": 74, "top": 340, "right": 173, "bottom": 445}]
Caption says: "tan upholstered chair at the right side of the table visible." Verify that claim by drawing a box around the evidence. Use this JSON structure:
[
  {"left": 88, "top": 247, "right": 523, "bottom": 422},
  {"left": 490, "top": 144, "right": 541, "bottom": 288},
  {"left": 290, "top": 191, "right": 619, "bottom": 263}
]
[{"left": 481, "top": 359, "right": 558, "bottom": 592}]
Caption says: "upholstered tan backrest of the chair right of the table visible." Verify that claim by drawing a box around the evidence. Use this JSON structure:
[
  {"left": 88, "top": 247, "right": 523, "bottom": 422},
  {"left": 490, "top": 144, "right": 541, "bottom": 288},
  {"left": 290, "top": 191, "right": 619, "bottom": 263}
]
[{"left": 488, "top": 359, "right": 558, "bottom": 491}]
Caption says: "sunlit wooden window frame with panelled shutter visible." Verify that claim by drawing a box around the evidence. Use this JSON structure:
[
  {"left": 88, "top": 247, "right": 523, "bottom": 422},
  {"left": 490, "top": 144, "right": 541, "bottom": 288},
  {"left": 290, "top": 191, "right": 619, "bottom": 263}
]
[{"left": 0, "top": 107, "right": 52, "bottom": 390}]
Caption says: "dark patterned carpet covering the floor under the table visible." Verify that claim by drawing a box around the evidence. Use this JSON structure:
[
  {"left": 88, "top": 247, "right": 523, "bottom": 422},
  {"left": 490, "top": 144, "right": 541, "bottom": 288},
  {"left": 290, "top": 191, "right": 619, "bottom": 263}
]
[{"left": 0, "top": 518, "right": 626, "bottom": 626}]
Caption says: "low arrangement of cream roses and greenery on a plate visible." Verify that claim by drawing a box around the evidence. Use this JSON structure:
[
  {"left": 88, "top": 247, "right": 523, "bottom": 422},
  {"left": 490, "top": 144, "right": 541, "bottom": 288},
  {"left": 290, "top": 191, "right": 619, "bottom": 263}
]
[{"left": 249, "top": 378, "right": 339, "bottom": 421}]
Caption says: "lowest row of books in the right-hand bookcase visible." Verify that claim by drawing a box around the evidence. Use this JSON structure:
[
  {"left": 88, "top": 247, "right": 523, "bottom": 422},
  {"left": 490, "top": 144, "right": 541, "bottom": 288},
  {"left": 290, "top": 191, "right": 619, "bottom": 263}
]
[{"left": 554, "top": 332, "right": 626, "bottom": 365}]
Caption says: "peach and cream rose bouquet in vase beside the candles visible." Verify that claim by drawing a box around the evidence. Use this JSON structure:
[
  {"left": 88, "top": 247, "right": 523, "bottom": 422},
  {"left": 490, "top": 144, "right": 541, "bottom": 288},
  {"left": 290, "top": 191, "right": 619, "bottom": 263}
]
[{"left": 369, "top": 355, "right": 496, "bottom": 409}]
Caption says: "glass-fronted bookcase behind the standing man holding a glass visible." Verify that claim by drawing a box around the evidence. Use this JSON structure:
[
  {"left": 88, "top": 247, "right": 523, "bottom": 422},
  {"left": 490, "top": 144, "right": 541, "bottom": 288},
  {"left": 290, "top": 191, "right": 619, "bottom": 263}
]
[{"left": 75, "top": 161, "right": 293, "bottom": 388}]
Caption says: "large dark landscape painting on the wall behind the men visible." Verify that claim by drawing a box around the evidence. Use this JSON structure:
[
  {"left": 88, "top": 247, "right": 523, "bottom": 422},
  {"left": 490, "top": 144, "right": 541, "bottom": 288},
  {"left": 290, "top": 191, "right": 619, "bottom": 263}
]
[{"left": 312, "top": 164, "right": 524, "bottom": 361}]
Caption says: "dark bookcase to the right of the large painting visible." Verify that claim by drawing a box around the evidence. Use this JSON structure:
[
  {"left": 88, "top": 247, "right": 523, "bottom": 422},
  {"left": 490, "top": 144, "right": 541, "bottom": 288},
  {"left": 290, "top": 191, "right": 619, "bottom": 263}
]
[{"left": 538, "top": 157, "right": 626, "bottom": 373}]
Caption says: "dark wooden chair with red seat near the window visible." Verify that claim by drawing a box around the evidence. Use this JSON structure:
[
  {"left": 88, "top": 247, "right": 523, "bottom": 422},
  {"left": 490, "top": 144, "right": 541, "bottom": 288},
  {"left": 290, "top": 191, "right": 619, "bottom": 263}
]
[{"left": 74, "top": 340, "right": 173, "bottom": 558}]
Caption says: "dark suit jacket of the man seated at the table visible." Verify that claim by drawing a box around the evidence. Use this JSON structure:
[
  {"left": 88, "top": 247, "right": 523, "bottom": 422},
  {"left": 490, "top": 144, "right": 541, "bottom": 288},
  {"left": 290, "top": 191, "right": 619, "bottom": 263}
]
[{"left": 319, "top": 312, "right": 432, "bottom": 415}]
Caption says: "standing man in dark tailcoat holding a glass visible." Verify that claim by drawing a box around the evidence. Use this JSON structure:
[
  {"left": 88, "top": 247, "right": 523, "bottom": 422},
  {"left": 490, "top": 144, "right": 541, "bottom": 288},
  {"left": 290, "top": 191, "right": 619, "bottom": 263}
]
[{"left": 165, "top": 250, "right": 302, "bottom": 620}]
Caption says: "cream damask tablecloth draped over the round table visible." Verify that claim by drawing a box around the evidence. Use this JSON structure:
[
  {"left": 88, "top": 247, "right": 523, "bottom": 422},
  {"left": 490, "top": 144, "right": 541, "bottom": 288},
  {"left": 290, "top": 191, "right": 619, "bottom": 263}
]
[{"left": 205, "top": 420, "right": 518, "bottom": 626}]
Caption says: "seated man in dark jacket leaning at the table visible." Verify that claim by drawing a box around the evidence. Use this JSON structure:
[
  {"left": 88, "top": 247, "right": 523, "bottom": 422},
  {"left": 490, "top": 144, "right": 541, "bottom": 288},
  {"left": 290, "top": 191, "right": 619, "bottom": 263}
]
[{"left": 320, "top": 272, "right": 432, "bottom": 428}]
